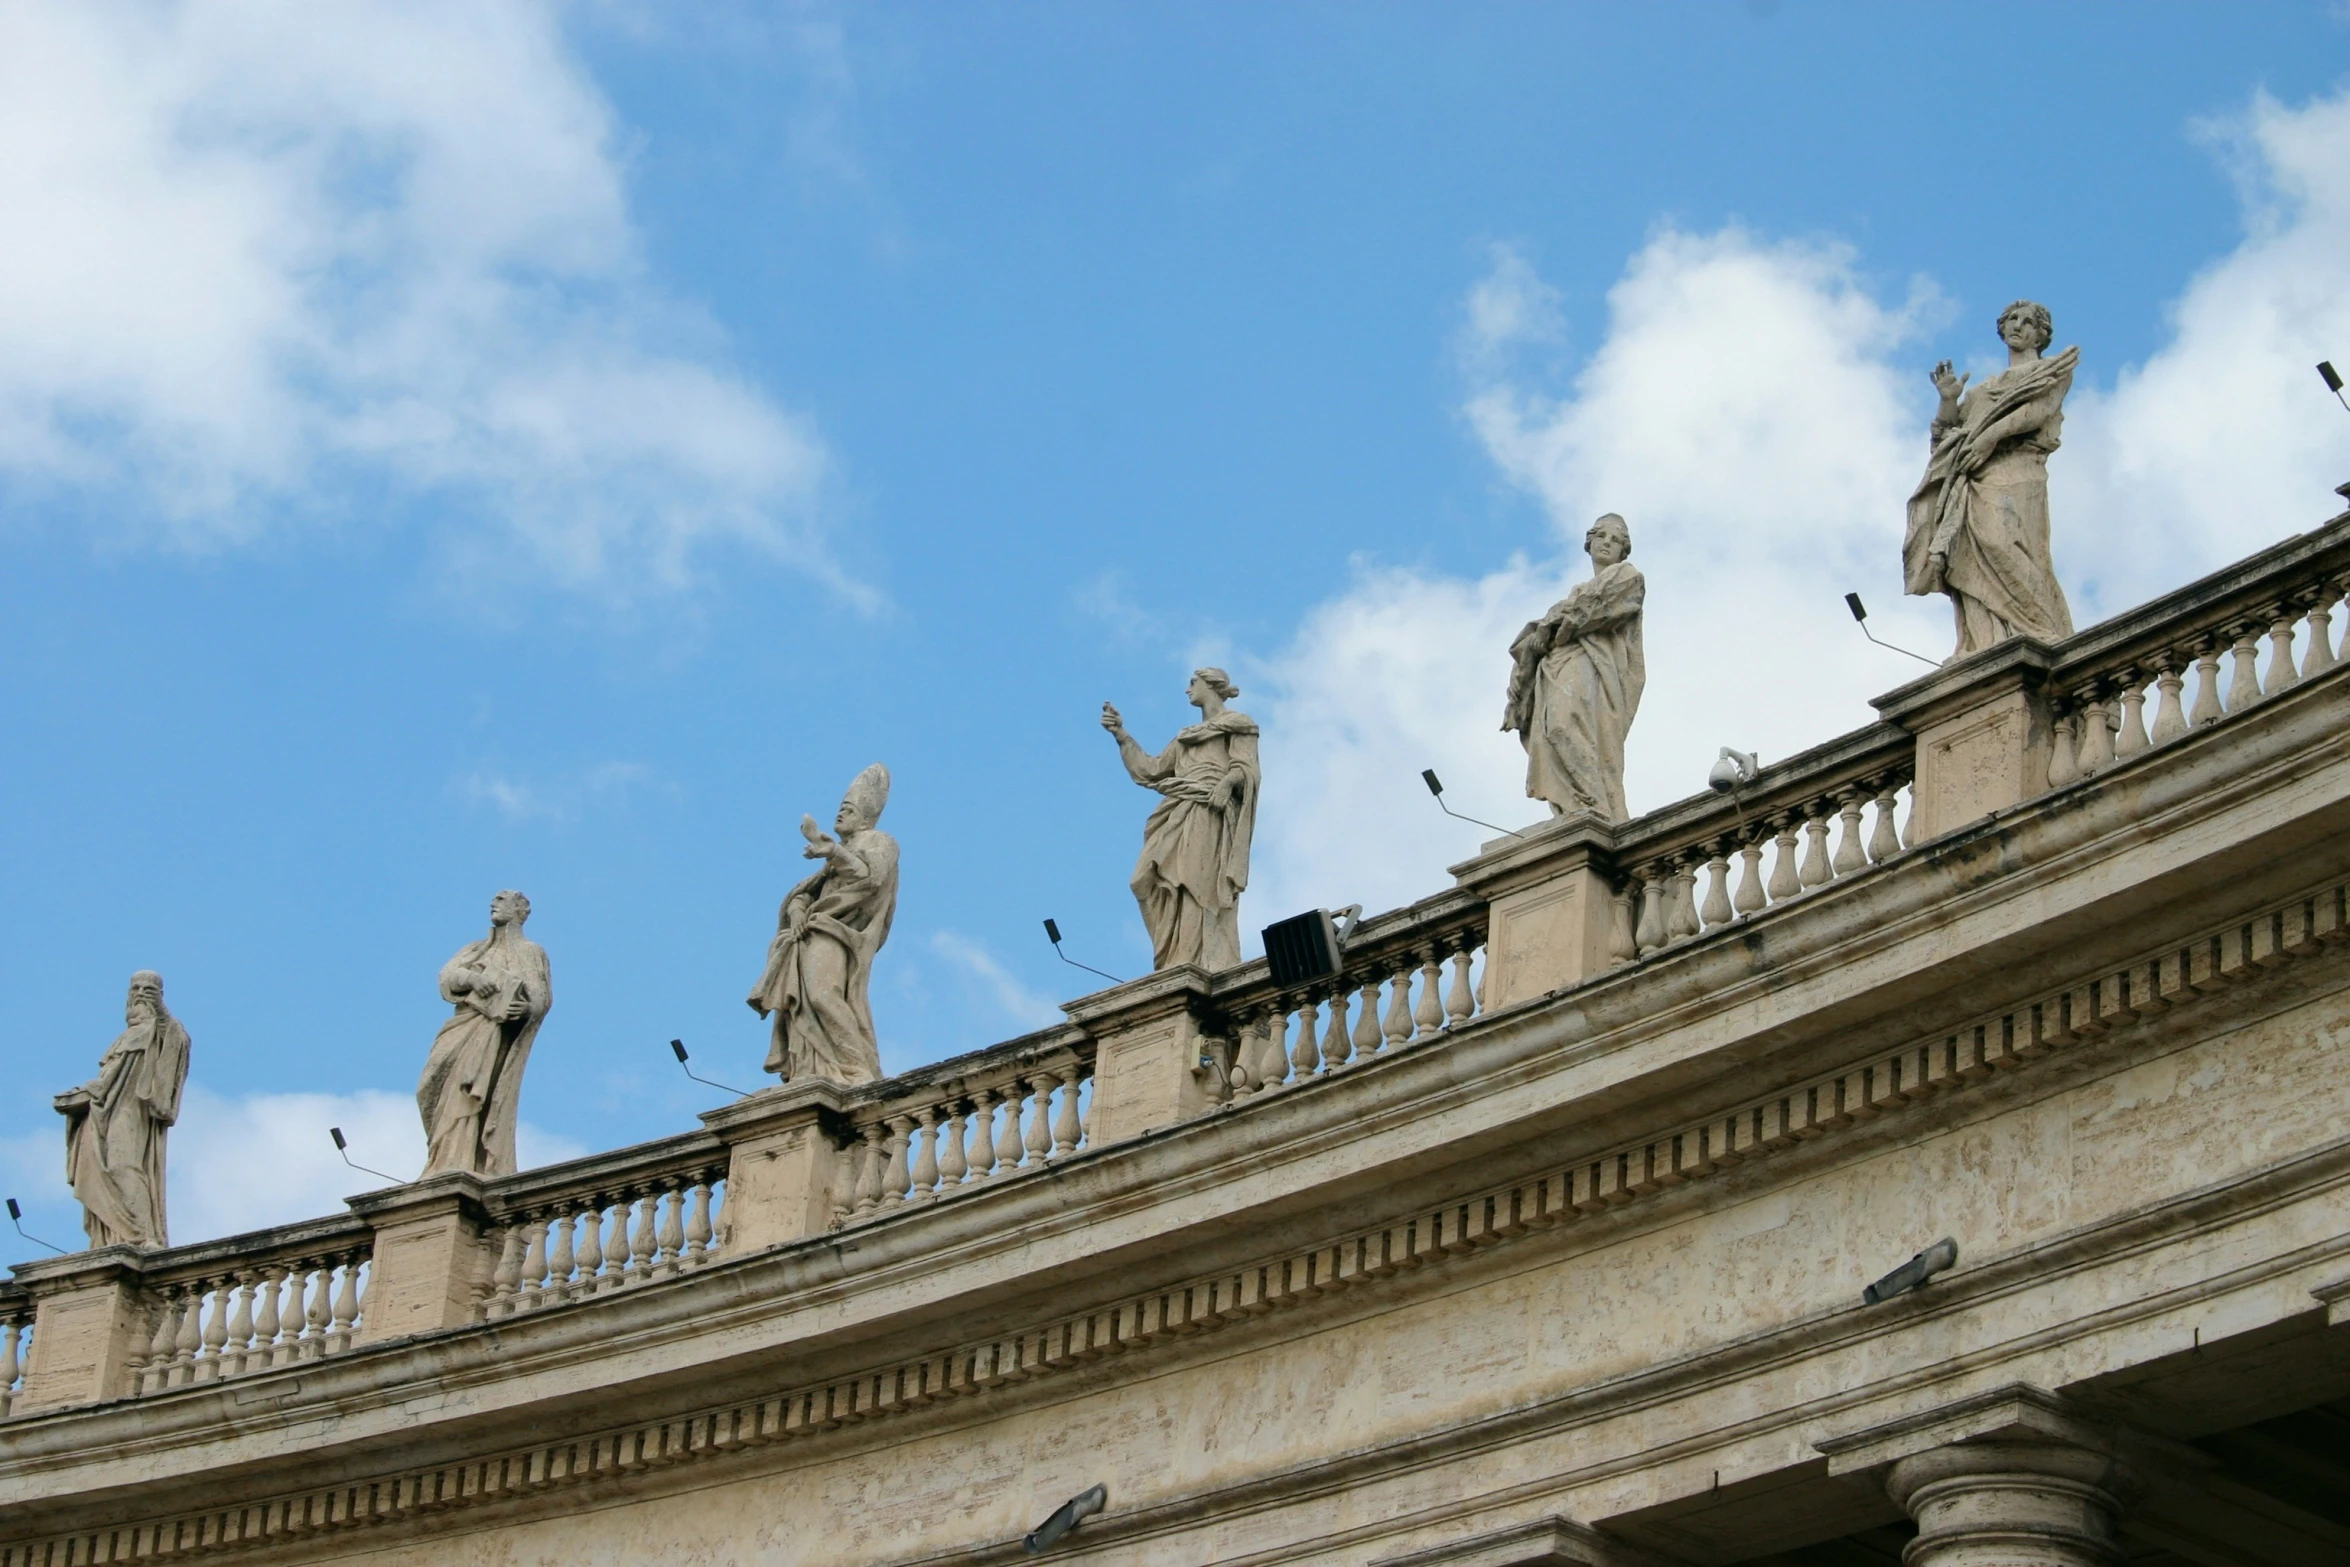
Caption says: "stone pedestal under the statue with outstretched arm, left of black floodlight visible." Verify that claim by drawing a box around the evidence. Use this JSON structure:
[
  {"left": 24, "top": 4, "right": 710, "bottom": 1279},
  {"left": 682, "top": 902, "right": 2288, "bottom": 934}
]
[{"left": 1062, "top": 966, "right": 1217, "bottom": 1146}]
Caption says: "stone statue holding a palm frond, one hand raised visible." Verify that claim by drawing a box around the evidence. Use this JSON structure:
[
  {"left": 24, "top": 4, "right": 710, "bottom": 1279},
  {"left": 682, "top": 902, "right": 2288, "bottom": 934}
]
[{"left": 1901, "top": 298, "right": 2080, "bottom": 660}]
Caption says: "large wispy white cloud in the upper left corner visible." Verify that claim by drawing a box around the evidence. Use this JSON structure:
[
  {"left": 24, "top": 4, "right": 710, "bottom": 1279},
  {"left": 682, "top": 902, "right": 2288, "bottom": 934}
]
[{"left": 0, "top": 0, "right": 845, "bottom": 601}]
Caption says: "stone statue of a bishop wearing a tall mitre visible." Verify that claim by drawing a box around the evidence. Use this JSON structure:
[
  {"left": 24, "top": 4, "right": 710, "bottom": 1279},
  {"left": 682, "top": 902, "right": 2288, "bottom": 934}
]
[{"left": 750, "top": 761, "right": 898, "bottom": 1083}]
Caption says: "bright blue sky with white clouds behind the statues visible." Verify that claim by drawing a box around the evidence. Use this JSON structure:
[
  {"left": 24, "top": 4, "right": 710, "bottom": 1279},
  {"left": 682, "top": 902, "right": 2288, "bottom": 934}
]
[{"left": 0, "top": 2, "right": 2350, "bottom": 1240}]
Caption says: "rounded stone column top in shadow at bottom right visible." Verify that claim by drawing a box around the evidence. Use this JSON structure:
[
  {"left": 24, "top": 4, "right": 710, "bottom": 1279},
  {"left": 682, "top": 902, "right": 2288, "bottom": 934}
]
[{"left": 1885, "top": 1442, "right": 2136, "bottom": 1567}]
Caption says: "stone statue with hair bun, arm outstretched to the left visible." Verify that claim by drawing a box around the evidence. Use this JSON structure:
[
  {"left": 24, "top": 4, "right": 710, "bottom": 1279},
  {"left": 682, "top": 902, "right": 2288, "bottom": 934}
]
[{"left": 1102, "top": 670, "right": 1264, "bottom": 973}]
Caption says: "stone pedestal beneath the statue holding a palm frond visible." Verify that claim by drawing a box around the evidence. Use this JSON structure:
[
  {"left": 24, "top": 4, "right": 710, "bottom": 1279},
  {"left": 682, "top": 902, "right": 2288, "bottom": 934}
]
[{"left": 1873, "top": 637, "right": 2054, "bottom": 843}]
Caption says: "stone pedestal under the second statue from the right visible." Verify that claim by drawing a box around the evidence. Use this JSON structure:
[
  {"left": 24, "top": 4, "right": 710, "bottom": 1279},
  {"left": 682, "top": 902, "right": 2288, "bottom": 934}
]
[{"left": 1452, "top": 815, "right": 1614, "bottom": 1013}]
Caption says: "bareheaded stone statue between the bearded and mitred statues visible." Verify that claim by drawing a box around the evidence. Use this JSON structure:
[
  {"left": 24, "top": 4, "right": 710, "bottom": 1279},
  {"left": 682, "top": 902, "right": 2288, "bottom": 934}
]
[{"left": 416, "top": 893, "right": 555, "bottom": 1179}]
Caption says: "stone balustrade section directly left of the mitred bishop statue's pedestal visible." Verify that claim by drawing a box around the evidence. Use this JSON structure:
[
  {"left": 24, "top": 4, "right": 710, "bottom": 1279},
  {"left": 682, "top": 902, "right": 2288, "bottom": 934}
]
[{"left": 479, "top": 1132, "right": 726, "bottom": 1320}]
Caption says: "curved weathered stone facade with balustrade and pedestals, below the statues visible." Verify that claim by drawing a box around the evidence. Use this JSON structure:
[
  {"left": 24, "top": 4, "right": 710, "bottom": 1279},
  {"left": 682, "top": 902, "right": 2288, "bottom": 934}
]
[{"left": 0, "top": 515, "right": 2350, "bottom": 1567}]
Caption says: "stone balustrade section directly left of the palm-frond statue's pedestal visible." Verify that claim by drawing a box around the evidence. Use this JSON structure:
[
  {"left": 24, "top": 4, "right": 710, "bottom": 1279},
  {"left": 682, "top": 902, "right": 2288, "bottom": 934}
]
[{"left": 1610, "top": 724, "right": 1918, "bottom": 963}]
